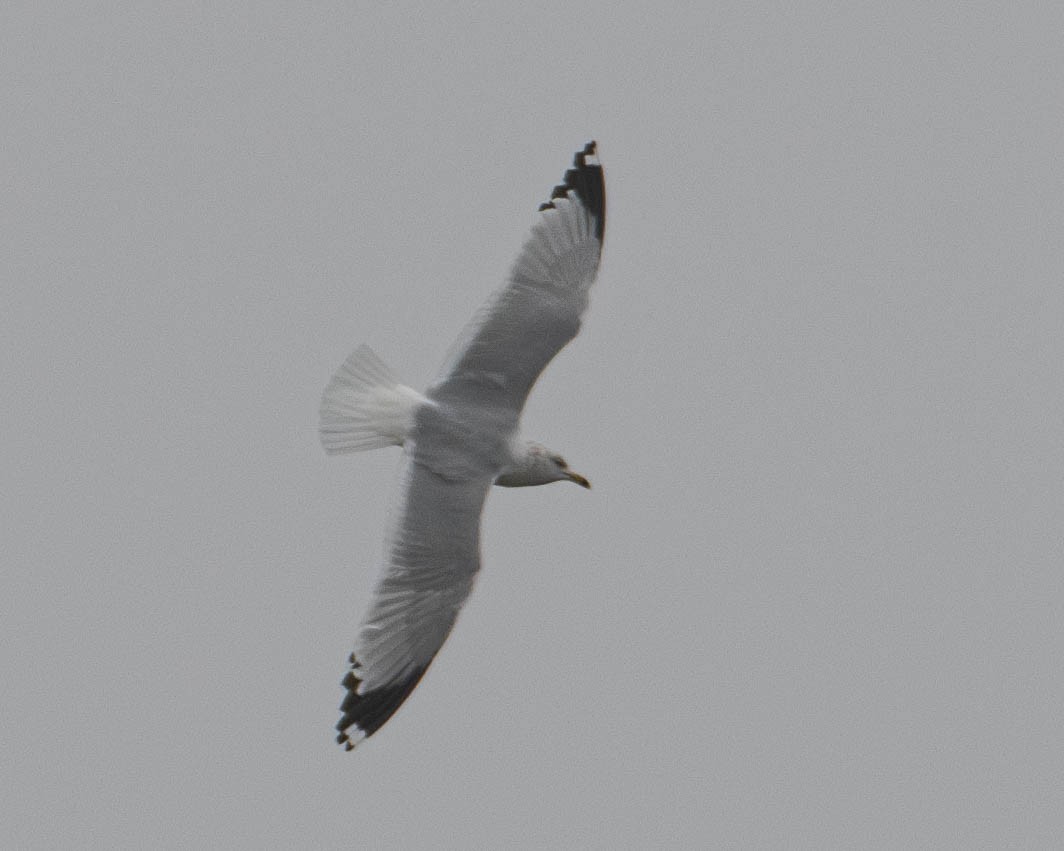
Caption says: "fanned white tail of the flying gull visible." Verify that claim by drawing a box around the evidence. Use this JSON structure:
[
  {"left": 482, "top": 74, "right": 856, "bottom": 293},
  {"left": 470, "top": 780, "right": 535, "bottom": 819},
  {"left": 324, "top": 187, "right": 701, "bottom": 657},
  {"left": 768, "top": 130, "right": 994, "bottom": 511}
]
[{"left": 318, "top": 346, "right": 428, "bottom": 455}]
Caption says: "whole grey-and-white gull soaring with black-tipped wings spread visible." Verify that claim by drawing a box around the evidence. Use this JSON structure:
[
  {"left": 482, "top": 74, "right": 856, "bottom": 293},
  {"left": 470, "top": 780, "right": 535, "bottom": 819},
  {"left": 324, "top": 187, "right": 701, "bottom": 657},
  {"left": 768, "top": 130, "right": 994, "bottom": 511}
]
[{"left": 318, "top": 141, "right": 605, "bottom": 751}]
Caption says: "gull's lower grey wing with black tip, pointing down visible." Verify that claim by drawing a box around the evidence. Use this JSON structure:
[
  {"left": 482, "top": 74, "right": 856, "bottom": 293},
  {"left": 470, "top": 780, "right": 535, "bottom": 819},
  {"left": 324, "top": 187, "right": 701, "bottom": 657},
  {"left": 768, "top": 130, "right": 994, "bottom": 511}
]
[{"left": 336, "top": 455, "right": 494, "bottom": 750}]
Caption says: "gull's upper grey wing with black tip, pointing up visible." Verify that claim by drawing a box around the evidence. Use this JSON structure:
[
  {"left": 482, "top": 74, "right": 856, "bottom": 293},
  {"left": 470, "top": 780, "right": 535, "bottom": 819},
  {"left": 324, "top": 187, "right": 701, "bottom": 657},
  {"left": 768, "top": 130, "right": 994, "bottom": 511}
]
[{"left": 428, "top": 141, "right": 605, "bottom": 424}]
